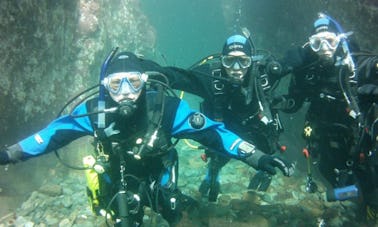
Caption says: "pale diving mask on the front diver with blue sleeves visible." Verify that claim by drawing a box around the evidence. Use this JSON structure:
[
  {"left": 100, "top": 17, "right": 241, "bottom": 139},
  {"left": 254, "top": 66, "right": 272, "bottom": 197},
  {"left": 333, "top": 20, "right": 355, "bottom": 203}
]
[{"left": 102, "top": 72, "right": 148, "bottom": 95}]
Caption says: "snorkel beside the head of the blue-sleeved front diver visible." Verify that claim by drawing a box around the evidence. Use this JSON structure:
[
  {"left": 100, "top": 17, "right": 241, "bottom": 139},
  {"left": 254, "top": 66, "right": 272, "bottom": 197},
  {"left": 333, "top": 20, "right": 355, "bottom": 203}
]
[{"left": 97, "top": 47, "right": 118, "bottom": 129}]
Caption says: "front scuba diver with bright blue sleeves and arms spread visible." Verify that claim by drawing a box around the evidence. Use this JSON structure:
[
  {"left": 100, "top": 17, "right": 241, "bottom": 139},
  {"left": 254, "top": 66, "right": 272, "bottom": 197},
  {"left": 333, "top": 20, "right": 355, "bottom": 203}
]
[{"left": 0, "top": 48, "right": 293, "bottom": 226}]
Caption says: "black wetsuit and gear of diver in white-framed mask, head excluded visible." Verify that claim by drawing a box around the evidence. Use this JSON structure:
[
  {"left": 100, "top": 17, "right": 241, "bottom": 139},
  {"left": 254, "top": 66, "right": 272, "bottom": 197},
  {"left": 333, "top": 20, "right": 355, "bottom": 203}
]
[{"left": 285, "top": 46, "right": 378, "bottom": 211}]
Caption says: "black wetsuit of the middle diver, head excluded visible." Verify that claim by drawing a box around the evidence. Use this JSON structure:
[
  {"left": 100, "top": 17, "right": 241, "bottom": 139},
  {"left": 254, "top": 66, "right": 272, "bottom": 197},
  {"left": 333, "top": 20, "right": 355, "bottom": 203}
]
[{"left": 160, "top": 52, "right": 282, "bottom": 201}]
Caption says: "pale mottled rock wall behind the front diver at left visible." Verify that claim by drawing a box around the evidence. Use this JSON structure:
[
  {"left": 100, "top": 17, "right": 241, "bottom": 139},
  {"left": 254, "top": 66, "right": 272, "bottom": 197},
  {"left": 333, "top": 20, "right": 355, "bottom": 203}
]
[{"left": 0, "top": 0, "right": 155, "bottom": 144}]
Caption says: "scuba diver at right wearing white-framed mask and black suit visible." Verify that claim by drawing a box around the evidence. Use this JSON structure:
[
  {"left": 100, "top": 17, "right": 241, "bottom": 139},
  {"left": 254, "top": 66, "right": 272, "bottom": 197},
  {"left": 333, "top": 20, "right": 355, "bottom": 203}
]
[{"left": 283, "top": 13, "right": 378, "bottom": 222}]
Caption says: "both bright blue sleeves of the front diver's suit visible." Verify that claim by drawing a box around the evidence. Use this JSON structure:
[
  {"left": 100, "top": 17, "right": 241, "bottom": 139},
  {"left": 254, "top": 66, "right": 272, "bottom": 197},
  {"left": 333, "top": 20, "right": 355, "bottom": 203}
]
[{"left": 18, "top": 93, "right": 239, "bottom": 159}]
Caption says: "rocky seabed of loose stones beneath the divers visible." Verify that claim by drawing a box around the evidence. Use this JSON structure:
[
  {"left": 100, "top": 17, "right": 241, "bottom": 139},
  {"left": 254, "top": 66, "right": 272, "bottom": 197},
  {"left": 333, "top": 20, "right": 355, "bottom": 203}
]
[{"left": 0, "top": 143, "right": 369, "bottom": 227}]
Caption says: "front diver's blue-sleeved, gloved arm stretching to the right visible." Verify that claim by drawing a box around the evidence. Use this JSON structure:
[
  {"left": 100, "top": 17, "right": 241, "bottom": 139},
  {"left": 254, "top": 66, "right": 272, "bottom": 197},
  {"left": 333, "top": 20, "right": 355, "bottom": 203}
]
[{"left": 172, "top": 98, "right": 294, "bottom": 176}]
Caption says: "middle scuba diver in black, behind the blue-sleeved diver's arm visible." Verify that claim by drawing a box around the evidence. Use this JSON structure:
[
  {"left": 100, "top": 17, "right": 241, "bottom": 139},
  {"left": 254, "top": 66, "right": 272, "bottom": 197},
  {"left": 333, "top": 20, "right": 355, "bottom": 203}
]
[{"left": 159, "top": 34, "right": 292, "bottom": 202}]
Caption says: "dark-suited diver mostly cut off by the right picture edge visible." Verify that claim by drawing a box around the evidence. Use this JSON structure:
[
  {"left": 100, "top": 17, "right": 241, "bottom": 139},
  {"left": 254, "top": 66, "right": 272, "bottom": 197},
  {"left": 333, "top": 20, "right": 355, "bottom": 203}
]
[{"left": 352, "top": 44, "right": 378, "bottom": 224}]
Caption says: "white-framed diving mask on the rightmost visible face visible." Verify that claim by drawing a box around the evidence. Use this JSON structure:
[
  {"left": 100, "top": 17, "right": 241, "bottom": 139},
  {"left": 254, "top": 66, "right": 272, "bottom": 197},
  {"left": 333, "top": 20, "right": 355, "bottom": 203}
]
[{"left": 309, "top": 32, "right": 341, "bottom": 52}]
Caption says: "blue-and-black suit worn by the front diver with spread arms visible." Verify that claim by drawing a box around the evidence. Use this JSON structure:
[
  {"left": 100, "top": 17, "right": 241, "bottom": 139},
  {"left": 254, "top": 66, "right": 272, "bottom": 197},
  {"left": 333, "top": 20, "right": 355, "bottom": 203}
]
[{"left": 12, "top": 86, "right": 248, "bottom": 223}]
